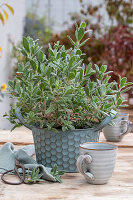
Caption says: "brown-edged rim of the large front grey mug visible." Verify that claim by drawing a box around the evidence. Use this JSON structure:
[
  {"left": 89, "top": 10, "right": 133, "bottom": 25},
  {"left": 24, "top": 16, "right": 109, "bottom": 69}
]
[{"left": 80, "top": 142, "right": 118, "bottom": 151}]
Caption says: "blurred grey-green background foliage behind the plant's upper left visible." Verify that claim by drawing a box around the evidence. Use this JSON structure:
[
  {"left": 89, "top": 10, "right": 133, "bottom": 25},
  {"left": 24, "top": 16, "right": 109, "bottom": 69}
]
[{"left": 9, "top": 8, "right": 52, "bottom": 76}]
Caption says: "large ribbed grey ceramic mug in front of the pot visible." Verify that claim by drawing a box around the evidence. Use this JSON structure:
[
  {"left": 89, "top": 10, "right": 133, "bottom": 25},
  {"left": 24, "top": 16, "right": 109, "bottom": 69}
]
[{"left": 77, "top": 142, "right": 117, "bottom": 184}]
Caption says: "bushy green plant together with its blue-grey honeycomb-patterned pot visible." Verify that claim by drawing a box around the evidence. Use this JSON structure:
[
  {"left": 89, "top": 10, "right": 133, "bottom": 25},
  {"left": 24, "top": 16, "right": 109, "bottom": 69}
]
[{"left": 6, "top": 22, "right": 130, "bottom": 172}]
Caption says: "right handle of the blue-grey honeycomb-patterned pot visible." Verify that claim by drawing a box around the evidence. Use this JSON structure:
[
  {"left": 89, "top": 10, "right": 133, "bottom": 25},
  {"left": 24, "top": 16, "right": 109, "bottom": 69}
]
[{"left": 94, "top": 110, "right": 117, "bottom": 131}]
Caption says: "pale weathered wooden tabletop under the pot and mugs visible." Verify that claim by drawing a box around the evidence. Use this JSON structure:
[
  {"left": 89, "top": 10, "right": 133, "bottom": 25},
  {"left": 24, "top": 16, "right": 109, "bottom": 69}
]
[{"left": 0, "top": 128, "right": 133, "bottom": 200}]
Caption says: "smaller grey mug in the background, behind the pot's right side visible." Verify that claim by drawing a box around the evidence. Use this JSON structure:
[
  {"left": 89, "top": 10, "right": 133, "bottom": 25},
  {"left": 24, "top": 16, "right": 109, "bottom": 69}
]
[{"left": 103, "top": 113, "right": 132, "bottom": 142}]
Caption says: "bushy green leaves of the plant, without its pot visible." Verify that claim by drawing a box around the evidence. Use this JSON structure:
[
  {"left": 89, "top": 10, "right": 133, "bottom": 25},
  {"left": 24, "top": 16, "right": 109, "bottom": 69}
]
[{"left": 4, "top": 23, "right": 132, "bottom": 131}]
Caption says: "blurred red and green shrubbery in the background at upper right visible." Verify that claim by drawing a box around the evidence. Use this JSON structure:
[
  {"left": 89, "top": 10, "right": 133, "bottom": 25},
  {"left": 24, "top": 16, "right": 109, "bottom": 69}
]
[{"left": 51, "top": 0, "right": 133, "bottom": 85}]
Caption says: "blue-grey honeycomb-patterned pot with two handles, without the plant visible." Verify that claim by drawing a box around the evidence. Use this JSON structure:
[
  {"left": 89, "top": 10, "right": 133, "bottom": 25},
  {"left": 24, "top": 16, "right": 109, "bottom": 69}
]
[{"left": 16, "top": 108, "right": 116, "bottom": 172}]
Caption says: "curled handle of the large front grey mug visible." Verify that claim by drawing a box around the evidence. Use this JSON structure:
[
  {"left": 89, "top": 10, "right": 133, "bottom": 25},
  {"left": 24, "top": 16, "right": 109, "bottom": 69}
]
[{"left": 76, "top": 155, "right": 94, "bottom": 180}]
